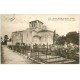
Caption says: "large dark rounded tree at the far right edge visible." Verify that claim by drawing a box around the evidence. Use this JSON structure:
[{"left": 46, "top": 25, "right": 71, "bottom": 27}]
[{"left": 66, "top": 32, "right": 79, "bottom": 45}]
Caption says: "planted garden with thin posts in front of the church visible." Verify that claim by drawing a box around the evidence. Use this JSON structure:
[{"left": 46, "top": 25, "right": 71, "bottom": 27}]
[{"left": 8, "top": 44, "right": 79, "bottom": 63}]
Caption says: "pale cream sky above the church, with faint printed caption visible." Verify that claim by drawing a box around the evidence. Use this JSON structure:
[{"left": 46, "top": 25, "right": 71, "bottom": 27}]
[{"left": 0, "top": 14, "right": 80, "bottom": 37}]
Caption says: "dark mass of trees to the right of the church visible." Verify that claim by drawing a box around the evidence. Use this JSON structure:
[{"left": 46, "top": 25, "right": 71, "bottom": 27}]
[{"left": 56, "top": 32, "right": 79, "bottom": 45}]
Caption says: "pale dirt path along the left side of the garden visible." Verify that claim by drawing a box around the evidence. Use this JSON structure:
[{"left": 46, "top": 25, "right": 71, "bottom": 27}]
[{"left": 2, "top": 46, "right": 32, "bottom": 64}]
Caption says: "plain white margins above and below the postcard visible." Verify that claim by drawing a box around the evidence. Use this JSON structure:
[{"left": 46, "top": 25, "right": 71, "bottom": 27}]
[{"left": 0, "top": 0, "right": 80, "bottom": 80}]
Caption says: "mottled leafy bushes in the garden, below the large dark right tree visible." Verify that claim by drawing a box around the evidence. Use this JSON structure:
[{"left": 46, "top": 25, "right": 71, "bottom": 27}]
[{"left": 53, "top": 45, "right": 79, "bottom": 61}]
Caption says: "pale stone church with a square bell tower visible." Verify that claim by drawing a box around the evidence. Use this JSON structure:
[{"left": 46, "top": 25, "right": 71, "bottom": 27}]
[{"left": 12, "top": 20, "right": 58, "bottom": 45}]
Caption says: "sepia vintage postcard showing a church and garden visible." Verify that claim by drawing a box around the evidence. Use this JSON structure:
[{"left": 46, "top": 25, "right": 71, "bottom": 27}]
[{"left": 0, "top": 14, "right": 80, "bottom": 64}]
